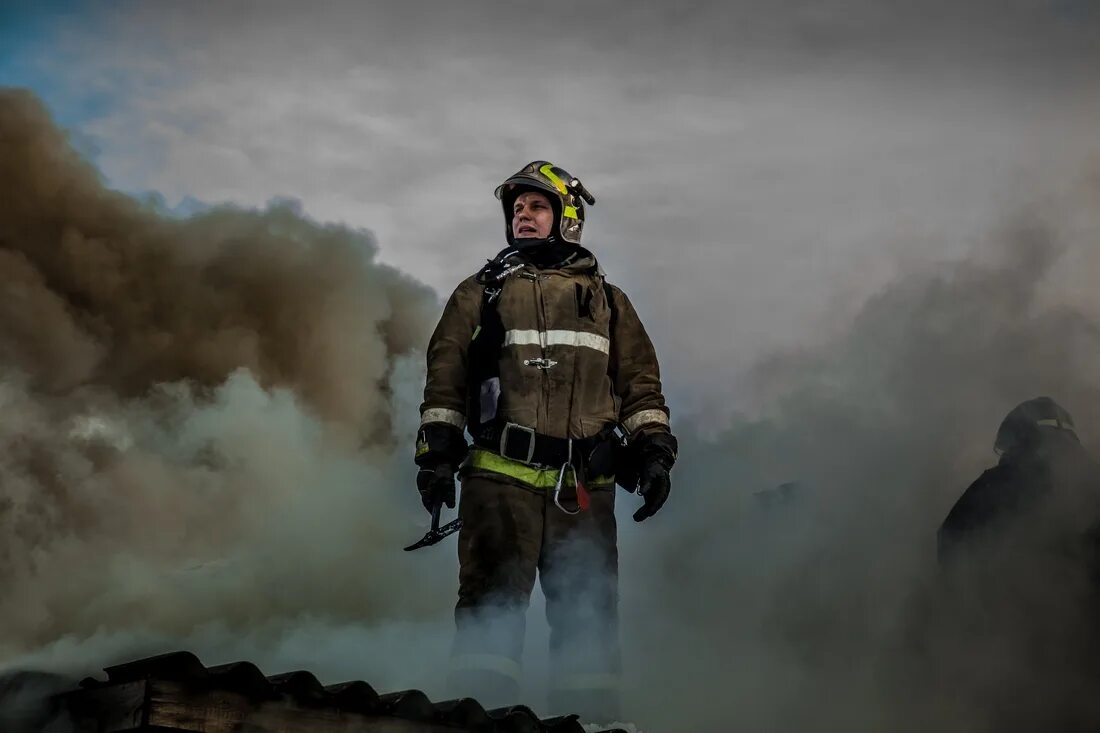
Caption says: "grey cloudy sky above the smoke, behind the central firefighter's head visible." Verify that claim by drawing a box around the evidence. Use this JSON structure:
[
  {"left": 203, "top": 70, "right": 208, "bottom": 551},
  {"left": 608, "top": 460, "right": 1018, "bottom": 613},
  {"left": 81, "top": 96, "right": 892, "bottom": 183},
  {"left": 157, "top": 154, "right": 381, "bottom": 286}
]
[{"left": 34, "top": 1, "right": 1100, "bottom": 416}]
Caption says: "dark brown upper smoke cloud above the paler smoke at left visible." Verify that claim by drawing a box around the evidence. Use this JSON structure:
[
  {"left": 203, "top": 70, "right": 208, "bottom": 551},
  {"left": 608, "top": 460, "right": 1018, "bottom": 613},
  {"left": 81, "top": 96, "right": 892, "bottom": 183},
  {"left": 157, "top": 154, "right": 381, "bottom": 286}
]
[{"left": 0, "top": 86, "right": 435, "bottom": 424}]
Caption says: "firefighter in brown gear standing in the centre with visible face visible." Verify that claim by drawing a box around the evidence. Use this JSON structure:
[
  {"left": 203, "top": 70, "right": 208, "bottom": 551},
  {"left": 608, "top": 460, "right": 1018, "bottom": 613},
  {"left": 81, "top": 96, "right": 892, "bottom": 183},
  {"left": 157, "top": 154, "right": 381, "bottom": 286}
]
[{"left": 416, "top": 161, "right": 677, "bottom": 720}]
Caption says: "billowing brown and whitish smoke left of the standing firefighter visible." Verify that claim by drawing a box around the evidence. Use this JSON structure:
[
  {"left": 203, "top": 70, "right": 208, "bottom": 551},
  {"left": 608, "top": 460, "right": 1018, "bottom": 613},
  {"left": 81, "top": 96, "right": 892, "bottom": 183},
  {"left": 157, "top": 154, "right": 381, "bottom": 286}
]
[{"left": 0, "top": 90, "right": 453, "bottom": 678}]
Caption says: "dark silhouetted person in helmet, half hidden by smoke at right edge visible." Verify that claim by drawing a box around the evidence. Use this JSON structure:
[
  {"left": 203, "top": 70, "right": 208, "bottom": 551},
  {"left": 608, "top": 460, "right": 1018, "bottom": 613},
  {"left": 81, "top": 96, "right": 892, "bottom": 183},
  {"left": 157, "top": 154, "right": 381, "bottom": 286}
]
[{"left": 937, "top": 397, "right": 1100, "bottom": 731}]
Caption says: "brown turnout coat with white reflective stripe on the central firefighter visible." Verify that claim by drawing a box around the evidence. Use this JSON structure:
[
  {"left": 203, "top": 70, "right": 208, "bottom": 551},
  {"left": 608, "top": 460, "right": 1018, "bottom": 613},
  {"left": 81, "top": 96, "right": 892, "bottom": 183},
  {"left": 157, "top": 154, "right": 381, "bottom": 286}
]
[{"left": 420, "top": 246, "right": 669, "bottom": 438}]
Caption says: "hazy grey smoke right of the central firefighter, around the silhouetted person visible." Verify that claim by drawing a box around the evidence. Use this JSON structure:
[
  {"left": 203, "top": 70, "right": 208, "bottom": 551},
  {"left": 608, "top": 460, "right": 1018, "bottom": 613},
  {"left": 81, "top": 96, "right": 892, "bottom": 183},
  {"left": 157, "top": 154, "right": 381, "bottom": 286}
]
[{"left": 624, "top": 181, "right": 1100, "bottom": 731}]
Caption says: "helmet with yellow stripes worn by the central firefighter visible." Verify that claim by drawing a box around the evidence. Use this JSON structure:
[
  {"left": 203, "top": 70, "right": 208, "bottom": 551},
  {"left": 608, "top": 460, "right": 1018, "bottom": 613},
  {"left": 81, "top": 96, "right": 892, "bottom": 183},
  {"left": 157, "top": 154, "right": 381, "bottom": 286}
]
[{"left": 495, "top": 161, "right": 596, "bottom": 244}]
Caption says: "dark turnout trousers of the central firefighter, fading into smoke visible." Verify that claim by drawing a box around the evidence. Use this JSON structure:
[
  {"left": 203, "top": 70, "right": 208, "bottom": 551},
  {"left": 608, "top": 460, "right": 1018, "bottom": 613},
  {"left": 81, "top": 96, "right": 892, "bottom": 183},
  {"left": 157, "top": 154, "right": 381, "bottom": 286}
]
[{"left": 450, "top": 473, "right": 622, "bottom": 721}]
